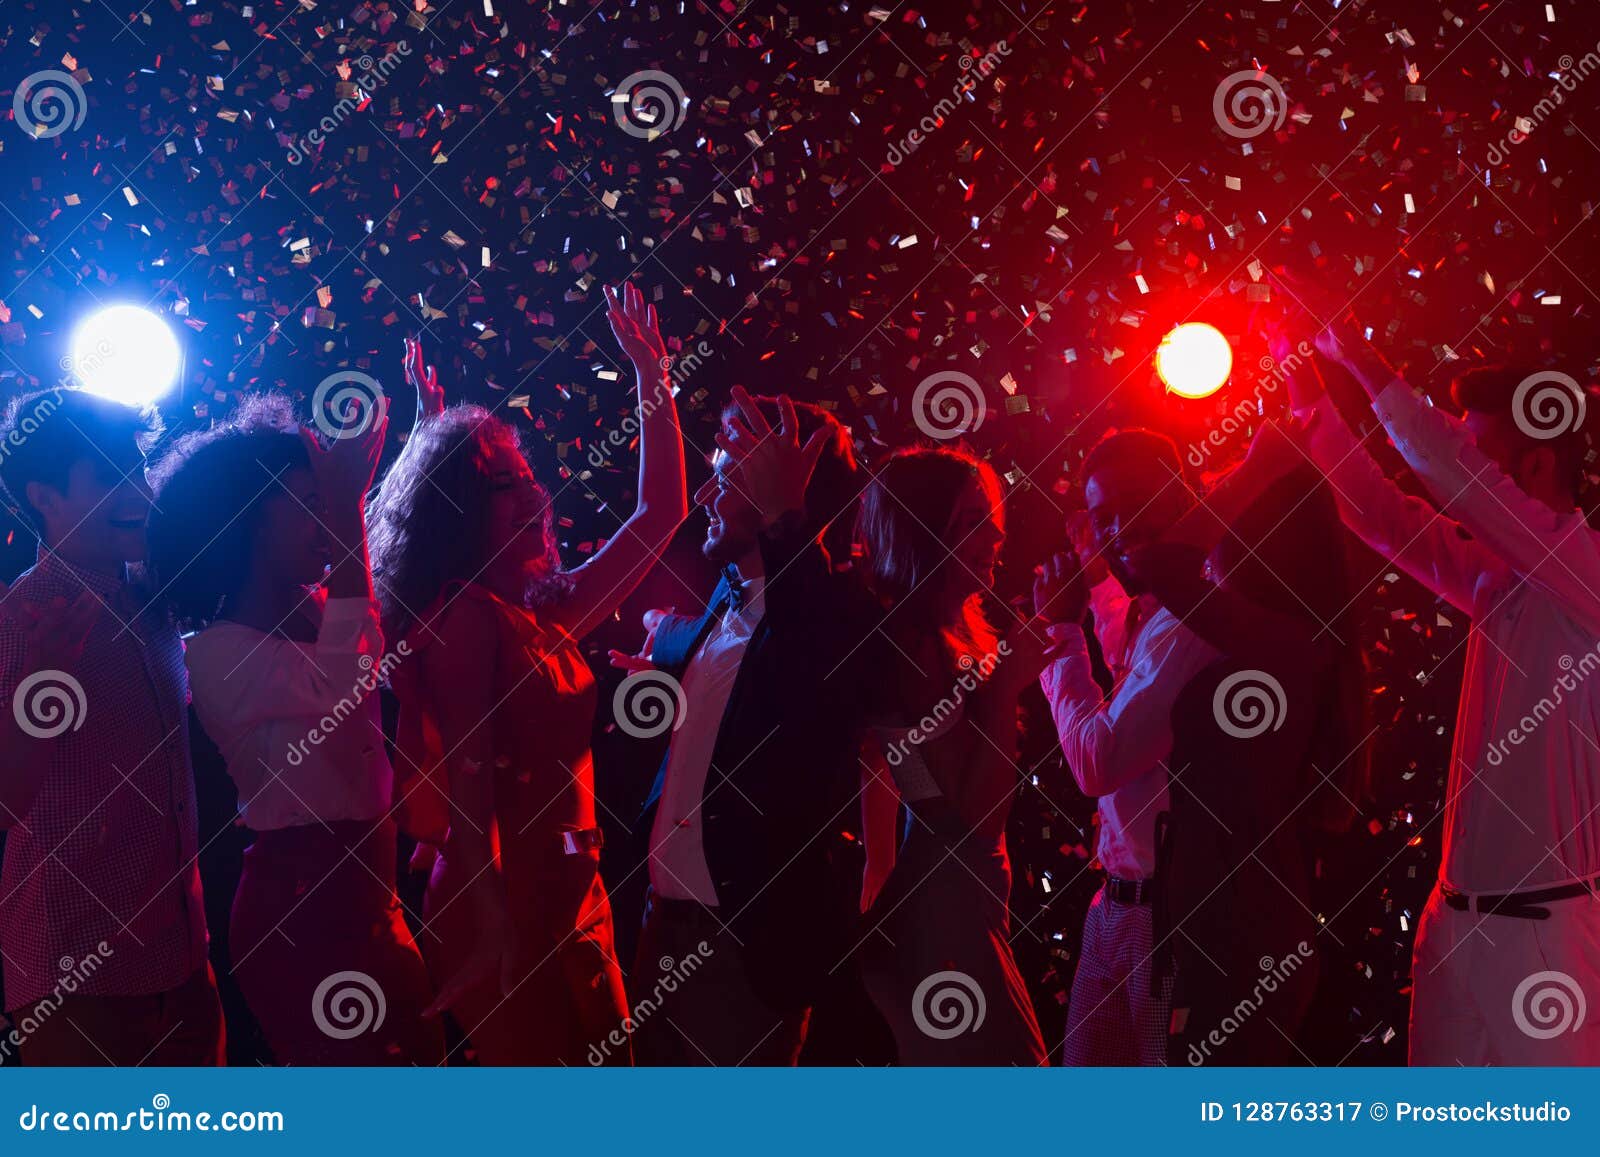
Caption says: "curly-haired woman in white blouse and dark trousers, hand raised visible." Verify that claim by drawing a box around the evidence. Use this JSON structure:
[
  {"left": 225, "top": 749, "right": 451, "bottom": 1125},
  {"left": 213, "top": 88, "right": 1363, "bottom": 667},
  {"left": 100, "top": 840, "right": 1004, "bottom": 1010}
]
[{"left": 150, "top": 395, "right": 445, "bottom": 1064}]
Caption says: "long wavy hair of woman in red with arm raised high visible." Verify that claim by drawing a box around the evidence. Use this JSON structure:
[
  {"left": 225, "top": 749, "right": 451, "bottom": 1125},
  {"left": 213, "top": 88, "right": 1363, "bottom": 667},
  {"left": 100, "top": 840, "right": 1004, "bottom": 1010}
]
[{"left": 366, "top": 405, "right": 570, "bottom": 639}]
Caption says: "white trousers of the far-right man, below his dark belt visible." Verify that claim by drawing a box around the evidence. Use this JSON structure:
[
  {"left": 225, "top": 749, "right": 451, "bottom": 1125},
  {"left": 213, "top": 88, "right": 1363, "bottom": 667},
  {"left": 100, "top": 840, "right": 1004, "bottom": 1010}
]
[{"left": 1411, "top": 888, "right": 1600, "bottom": 1066}]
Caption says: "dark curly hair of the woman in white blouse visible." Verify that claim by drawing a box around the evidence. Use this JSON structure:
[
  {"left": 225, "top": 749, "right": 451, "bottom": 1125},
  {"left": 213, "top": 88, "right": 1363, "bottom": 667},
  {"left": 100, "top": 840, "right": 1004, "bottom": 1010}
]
[{"left": 149, "top": 394, "right": 310, "bottom": 631}]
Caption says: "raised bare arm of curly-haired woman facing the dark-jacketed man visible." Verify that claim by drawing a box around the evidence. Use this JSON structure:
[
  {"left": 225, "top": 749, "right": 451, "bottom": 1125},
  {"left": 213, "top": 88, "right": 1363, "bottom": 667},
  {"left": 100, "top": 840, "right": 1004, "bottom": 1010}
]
[{"left": 549, "top": 285, "right": 690, "bottom": 639}]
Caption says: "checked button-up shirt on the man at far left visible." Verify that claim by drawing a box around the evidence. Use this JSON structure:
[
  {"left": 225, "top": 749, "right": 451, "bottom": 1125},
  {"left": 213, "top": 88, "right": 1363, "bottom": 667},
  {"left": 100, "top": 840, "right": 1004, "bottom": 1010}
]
[{"left": 0, "top": 550, "right": 206, "bottom": 1010}]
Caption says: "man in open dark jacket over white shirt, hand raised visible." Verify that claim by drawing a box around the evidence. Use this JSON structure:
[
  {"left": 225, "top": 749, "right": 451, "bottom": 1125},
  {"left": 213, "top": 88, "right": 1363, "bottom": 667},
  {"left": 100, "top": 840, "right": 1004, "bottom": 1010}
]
[{"left": 613, "top": 387, "right": 872, "bottom": 1066}]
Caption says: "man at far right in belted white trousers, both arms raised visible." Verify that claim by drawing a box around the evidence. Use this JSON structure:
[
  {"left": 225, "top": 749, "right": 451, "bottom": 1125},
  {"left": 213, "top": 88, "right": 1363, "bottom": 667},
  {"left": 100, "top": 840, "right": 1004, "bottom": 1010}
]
[{"left": 1290, "top": 282, "right": 1600, "bottom": 1064}]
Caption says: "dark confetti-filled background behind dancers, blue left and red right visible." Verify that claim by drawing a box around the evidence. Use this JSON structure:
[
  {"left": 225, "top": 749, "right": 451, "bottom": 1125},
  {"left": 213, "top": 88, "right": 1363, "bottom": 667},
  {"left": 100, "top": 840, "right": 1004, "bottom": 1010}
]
[{"left": 0, "top": 0, "right": 1600, "bottom": 1064}]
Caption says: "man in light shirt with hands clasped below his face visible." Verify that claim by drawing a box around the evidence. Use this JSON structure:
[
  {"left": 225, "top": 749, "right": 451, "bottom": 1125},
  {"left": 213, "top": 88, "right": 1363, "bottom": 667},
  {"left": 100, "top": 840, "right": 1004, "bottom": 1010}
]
[{"left": 1035, "top": 430, "right": 1218, "bottom": 1064}]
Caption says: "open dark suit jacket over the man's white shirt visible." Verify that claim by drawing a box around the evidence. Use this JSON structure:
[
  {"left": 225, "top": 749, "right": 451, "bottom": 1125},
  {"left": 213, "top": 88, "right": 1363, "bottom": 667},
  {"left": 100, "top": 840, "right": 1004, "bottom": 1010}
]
[{"left": 638, "top": 524, "right": 878, "bottom": 1010}]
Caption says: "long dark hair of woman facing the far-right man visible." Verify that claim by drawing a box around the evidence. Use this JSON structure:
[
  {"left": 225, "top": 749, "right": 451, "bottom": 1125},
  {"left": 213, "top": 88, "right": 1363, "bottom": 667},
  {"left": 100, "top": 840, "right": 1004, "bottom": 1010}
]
[{"left": 1214, "top": 464, "right": 1373, "bottom": 832}]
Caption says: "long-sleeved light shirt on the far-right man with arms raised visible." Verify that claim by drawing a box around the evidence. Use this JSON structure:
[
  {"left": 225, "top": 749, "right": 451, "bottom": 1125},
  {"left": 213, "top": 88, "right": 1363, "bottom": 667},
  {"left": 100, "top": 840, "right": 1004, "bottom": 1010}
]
[{"left": 1302, "top": 381, "right": 1600, "bottom": 893}]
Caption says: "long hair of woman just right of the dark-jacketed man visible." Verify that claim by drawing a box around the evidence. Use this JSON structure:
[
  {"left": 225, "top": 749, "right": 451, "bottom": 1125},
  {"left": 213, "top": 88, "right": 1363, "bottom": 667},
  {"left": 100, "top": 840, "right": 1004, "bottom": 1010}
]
[{"left": 856, "top": 446, "right": 1003, "bottom": 669}]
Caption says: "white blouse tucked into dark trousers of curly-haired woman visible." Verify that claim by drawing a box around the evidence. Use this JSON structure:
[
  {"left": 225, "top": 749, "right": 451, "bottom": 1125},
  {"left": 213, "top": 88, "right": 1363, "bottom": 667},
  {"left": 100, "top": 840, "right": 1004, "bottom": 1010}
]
[{"left": 186, "top": 599, "right": 396, "bottom": 832}]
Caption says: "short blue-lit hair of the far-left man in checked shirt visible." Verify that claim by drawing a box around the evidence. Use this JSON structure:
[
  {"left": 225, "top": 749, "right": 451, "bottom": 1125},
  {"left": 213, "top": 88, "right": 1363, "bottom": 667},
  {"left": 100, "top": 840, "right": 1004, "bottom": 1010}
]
[{"left": 0, "top": 387, "right": 160, "bottom": 534}]
